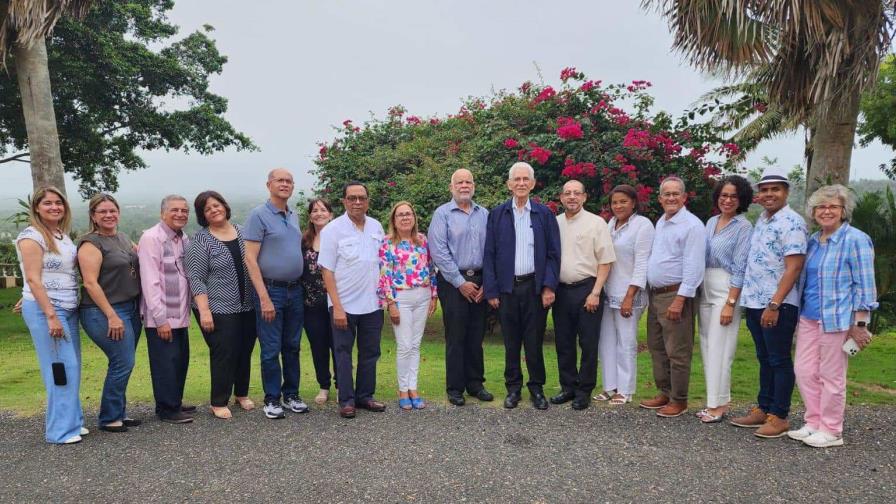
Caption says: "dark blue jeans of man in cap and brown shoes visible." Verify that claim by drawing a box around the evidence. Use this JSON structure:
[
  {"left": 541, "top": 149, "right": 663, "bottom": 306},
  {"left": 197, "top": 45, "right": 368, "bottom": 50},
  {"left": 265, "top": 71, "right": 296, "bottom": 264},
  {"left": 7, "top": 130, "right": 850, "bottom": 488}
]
[{"left": 746, "top": 304, "right": 799, "bottom": 418}]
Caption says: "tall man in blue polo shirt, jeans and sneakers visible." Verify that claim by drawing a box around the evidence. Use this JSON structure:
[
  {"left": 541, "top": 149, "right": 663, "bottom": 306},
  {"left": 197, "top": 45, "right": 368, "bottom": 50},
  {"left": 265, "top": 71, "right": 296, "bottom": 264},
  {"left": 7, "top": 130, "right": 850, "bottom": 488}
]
[{"left": 242, "top": 168, "right": 308, "bottom": 418}]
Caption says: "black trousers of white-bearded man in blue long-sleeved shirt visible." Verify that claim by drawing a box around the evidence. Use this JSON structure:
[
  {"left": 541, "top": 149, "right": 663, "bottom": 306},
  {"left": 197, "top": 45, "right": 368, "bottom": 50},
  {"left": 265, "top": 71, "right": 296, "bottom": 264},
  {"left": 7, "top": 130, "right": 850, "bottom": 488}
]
[{"left": 438, "top": 275, "right": 488, "bottom": 395}]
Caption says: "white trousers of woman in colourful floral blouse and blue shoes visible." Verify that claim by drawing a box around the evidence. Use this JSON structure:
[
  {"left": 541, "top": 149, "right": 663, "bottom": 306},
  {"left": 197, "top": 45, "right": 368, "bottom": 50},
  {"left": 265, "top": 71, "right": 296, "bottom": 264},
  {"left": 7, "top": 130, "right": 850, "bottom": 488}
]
[{"left": 392, "top": 286, "right": 432, "bottom": 392}]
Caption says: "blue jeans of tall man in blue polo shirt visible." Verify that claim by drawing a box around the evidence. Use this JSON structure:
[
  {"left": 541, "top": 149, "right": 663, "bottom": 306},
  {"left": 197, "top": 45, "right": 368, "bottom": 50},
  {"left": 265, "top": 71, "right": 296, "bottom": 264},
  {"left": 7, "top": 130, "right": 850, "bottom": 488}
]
[{"left": 255, "top": 283, "right": 305, "bottom": 402}]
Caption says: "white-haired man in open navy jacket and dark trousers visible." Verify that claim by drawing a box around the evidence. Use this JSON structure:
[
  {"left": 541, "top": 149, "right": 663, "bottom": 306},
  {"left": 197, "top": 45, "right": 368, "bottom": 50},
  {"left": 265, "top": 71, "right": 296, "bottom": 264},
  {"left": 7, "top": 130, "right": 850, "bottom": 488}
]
[{"left": 482, "top": 162, "right": 560, "bottom": 410}]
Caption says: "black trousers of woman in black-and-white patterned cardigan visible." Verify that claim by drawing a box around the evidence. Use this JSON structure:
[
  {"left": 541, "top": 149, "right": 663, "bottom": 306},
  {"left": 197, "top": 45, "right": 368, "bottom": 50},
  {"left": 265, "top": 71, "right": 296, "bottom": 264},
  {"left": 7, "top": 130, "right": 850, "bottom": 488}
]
[{"left": 193, "top": 310, "right": 258, "bottom": 406}]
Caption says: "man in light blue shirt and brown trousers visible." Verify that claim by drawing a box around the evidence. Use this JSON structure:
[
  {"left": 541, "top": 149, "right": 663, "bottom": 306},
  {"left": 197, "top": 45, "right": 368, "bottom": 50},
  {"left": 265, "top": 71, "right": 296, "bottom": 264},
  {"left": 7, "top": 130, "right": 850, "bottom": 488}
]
[{"left": 641, "top": 176, "right": 706, "bottom": 417}]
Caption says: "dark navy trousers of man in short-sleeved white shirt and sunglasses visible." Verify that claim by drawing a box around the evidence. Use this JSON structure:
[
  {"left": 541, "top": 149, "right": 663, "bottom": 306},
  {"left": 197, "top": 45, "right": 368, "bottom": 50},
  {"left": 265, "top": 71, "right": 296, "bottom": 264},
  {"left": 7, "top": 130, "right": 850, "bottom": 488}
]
[{"left": 330, "top": 310, "right": 383, "bottom": 406}]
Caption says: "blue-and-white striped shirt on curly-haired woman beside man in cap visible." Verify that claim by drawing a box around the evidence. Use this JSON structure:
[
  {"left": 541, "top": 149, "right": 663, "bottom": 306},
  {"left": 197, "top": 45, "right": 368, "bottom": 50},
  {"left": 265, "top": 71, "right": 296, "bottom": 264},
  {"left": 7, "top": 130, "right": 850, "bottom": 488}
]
[{"left": 706, "top": 214, "right": 753, "bottom": 289}]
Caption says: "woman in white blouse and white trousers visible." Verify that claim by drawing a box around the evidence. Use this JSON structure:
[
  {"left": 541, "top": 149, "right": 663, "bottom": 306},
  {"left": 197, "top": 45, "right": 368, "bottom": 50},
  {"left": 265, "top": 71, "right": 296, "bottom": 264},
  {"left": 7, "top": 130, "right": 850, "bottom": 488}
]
[{"left": 594, "top": 184, "right": 654, "bottom": 405}]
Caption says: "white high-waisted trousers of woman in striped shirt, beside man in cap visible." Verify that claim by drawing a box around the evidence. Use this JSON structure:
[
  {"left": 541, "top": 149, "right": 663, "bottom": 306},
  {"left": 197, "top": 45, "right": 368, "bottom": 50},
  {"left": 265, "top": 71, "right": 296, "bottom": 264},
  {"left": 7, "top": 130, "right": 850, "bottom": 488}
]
[{"left": 699, "top": 268, "right": 741, "bottom": 408}]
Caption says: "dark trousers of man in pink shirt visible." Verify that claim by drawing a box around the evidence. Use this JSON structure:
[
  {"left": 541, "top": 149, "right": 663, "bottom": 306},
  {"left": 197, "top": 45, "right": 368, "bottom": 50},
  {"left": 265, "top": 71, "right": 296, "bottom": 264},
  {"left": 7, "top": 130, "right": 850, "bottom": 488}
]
[{"left": 146, "top": 327, "right": 190, "bottom": 418}]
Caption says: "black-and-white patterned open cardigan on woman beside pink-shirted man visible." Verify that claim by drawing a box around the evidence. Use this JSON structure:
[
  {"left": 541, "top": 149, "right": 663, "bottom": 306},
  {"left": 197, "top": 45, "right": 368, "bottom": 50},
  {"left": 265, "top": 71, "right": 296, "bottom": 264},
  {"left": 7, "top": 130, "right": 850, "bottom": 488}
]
[{"left": 186, "top": 224, "right": 255, "bottom": 314}]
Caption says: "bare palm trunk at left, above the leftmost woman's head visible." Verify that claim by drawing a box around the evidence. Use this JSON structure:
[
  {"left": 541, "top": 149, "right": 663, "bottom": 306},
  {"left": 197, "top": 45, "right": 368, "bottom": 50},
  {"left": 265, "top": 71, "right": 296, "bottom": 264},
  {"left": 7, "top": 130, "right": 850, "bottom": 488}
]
[{"left": 13, "top": 38, "right": 65, "bottom": 197}]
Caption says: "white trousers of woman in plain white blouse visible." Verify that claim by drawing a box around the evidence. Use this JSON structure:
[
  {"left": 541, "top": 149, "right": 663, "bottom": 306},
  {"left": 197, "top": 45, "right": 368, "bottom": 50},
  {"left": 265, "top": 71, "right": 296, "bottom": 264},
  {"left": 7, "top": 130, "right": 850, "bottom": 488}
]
[{"left": 597, "top": 303, "right": 644, "bottom": 397}]
